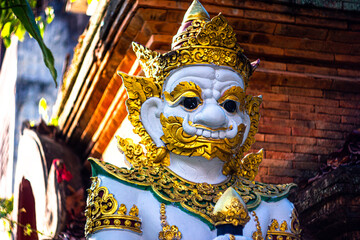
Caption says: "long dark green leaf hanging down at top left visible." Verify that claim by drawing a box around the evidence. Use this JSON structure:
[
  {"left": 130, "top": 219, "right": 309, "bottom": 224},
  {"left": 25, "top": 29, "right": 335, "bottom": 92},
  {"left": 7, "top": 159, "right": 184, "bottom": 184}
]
[{"left": 11, "top": 0, "right": 57, "bottom": 86}]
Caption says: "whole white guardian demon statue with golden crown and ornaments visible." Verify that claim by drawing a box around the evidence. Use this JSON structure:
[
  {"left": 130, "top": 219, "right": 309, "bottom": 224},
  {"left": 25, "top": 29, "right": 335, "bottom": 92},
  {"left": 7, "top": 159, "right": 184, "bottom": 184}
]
[{"left": 85, "top": 0, "right": 300, "bottom": 240}]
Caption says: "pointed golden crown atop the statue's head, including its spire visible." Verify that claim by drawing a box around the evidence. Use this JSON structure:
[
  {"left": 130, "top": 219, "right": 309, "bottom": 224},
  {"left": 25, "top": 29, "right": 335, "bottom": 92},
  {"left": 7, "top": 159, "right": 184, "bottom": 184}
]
[{"left": 133, "top": 0, "right": 256, "bottom": 89}]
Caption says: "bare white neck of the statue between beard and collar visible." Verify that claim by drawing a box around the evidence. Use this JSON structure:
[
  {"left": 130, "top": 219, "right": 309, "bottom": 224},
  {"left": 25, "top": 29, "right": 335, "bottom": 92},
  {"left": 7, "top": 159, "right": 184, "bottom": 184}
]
[{"left": 169, "top": 153, "right": 226, "bottom": 184}]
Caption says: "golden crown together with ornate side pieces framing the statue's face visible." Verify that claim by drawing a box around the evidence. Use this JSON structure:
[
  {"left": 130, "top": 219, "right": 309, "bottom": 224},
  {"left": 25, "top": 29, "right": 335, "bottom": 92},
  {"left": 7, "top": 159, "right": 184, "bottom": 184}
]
[{"left": 118, "top": 0, "right": 263, "bottom": 176}]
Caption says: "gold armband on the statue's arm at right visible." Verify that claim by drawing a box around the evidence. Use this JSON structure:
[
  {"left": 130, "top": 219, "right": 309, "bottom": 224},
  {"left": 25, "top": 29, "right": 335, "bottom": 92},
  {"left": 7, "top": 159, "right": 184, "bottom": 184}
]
[{"left": 266, "top": 211, "right": 301, "bottom": 240}]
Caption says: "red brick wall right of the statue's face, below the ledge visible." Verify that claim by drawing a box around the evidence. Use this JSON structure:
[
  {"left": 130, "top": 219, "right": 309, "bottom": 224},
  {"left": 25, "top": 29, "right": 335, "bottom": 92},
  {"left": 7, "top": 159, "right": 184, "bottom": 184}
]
[{"left": 248, "top": 69, "right": 360, "bottom": 182}]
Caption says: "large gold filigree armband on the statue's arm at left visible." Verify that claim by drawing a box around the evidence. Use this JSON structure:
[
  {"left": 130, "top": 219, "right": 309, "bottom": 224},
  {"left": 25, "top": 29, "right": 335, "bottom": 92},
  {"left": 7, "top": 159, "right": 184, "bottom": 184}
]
[{"left": 85, "top": 177, "right": 141, "bottom": 236}]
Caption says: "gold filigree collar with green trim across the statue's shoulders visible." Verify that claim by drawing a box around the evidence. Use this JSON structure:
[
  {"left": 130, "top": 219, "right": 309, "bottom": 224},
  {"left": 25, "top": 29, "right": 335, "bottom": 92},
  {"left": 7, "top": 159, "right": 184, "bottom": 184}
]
[{"left": 89, "top": 158, "right": 296, "bottom": 228}]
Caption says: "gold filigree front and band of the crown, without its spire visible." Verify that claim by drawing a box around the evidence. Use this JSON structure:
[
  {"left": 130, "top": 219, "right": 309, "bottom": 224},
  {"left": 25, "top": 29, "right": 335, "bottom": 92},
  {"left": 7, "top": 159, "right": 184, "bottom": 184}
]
[{"left": 133, "top": 14, "right": 252, "bottom": 91}]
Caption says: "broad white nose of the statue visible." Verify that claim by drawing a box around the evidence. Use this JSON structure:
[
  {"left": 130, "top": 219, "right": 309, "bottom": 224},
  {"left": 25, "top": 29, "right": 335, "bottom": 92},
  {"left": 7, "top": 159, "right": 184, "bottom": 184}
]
[{"left": 194, "top": 103, "right": 227, "bottom": 129}]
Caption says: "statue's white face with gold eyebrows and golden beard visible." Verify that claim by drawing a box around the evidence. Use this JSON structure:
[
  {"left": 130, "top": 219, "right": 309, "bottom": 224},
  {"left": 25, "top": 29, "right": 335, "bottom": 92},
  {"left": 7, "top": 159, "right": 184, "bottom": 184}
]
[{"left": 141, "top": 65, "right": 250, "bottom": 161}]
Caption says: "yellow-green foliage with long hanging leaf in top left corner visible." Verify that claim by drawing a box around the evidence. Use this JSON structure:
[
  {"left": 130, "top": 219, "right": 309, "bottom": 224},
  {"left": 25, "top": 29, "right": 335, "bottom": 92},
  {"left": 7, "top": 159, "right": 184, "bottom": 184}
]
[{"left": 0, "top": 0, "right": 57, "bottom": 86}]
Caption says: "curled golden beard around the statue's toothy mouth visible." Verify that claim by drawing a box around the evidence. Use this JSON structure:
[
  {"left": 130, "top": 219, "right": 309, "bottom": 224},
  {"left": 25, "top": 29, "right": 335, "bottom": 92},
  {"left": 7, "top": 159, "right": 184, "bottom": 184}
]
[{"left": 160, "top": 114, "right": 245, "bottom": 162}]
